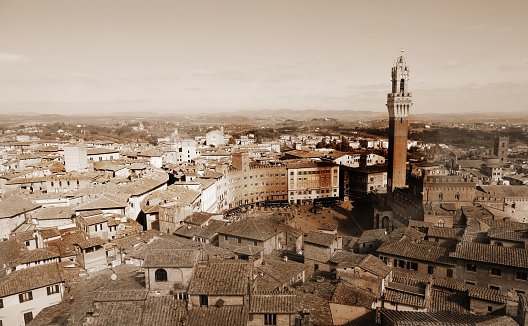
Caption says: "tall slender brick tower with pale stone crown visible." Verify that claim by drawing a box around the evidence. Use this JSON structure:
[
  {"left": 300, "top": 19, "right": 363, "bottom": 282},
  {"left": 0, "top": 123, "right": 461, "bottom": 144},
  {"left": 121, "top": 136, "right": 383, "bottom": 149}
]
[{"left": 387, "top": 51, "right": 412, "bottom": 192}]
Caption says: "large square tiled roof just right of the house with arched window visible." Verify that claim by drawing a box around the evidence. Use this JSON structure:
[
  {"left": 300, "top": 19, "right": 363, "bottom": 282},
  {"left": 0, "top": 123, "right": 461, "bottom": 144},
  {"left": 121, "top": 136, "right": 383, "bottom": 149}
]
[{"left": 188, "top": 259, "right": 251, "bottom": 295}]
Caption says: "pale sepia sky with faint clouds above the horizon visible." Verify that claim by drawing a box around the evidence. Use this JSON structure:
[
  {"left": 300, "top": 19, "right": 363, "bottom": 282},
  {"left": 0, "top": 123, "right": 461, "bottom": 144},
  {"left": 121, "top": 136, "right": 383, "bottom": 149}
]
[{"left": 0, "top": 0, "right": 528, "bottom": 114}]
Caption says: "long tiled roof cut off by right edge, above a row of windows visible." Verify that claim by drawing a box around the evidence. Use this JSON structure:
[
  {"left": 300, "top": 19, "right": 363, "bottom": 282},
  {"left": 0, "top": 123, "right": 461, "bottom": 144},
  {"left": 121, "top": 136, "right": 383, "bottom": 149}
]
[{"left": 450, "top": 242, "right": 528, "bottom": 268}]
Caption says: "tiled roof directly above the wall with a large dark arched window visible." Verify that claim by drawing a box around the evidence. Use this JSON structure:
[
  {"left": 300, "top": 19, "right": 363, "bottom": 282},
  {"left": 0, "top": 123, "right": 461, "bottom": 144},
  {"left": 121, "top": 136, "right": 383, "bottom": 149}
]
[{"left": 143, "top": 249, "right": 199, "bottom": 268}]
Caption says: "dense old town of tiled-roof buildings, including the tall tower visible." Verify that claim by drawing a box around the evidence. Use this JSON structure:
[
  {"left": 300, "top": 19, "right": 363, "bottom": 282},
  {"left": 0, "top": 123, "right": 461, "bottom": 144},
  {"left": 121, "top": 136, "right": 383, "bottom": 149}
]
[{"left": 0, "top": 56, "right": 528, "bottom": 326}]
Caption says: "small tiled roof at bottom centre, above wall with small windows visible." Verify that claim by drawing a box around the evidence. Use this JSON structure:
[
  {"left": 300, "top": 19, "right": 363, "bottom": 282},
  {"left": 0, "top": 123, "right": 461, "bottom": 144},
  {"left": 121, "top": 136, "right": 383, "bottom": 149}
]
[{"left": 249, "top": 293, "right": 297, "bottom": 314}]
